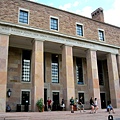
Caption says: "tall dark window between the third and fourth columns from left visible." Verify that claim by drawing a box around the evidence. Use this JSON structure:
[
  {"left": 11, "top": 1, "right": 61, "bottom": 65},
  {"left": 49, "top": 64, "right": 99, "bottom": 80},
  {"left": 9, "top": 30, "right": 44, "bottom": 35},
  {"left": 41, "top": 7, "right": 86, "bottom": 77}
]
[{"left": 76, "top": 58, "right": 84, "bottom": 85}]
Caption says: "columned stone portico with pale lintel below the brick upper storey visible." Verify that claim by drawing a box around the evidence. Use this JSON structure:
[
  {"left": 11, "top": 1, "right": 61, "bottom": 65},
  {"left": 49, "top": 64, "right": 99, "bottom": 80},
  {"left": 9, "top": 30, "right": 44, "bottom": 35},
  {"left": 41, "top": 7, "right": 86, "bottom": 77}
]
[{"left": 0, "top": 23, "right": 120, "bottom": 112}]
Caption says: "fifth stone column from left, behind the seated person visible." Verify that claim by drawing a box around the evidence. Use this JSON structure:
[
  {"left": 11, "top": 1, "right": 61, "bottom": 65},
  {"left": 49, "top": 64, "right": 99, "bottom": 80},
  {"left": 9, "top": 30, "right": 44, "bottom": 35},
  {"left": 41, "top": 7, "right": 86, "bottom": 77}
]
[{"left": 107, "top": 53, "right": 120, "bottom": 108}]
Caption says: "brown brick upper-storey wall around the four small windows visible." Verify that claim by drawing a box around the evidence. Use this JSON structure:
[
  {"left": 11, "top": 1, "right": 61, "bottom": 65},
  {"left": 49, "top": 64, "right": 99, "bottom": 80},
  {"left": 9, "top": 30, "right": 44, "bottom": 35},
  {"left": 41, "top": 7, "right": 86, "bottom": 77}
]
[{"left": 0, "top": 0, "right": 120, "bottom": 46}]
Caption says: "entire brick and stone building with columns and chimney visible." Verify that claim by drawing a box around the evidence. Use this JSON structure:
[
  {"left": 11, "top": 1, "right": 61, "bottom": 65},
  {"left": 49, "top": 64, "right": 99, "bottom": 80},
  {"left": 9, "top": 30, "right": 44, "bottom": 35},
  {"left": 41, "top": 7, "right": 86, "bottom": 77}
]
[{"left": 0, "top": 0, "right": 120, "bottom": 112}]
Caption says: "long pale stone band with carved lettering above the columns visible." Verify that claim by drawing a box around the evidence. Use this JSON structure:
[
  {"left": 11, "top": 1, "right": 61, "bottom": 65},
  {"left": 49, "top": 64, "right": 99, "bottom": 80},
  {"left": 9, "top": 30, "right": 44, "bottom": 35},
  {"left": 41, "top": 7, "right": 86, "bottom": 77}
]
[{"left": 0, "top": 21, "right": 120, "bottom": 54}]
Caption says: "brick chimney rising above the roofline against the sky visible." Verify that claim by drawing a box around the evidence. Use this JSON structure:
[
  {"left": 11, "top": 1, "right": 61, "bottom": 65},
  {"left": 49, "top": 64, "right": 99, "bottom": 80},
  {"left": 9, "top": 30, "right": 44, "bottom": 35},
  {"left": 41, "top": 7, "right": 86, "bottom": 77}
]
[{"left": 91, "top": 7, "right": 104, "bottom": 22}]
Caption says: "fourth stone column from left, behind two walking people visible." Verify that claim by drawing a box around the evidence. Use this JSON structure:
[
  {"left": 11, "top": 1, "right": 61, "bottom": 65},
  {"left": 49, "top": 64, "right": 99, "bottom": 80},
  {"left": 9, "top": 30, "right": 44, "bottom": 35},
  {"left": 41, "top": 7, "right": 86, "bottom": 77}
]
[{"left": 86, "top": 50, "right": 101, "bottom": 108}]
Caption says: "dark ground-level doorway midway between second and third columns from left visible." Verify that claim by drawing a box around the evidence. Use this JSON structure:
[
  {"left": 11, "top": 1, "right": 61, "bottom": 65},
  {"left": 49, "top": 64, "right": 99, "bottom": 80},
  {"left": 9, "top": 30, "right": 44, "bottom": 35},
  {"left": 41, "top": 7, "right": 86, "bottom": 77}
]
[{"left": 52, "top": 92, "right": 60, "bottom": 111}]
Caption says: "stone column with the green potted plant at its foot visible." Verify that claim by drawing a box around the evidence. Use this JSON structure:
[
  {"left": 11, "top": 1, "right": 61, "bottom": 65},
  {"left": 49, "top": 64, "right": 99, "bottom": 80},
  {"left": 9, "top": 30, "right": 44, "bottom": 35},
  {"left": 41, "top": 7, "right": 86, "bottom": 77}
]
[{"left": 31, "top": 40, "right": 44, "bottom": 111}]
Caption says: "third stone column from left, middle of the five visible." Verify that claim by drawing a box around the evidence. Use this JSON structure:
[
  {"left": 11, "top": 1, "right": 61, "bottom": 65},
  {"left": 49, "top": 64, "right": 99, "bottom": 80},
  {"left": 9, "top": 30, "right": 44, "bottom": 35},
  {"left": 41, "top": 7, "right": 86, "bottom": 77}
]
[{"left": 62, "top": 45, "right": 75, "bottom": 110}]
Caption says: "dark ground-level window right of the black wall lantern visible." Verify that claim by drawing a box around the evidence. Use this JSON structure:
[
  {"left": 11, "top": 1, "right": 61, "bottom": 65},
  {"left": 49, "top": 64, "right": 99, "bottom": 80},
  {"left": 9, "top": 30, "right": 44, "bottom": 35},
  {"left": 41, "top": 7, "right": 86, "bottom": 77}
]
[{"left": 21, "top": 91, "right": 30, "bottom": 105}]
